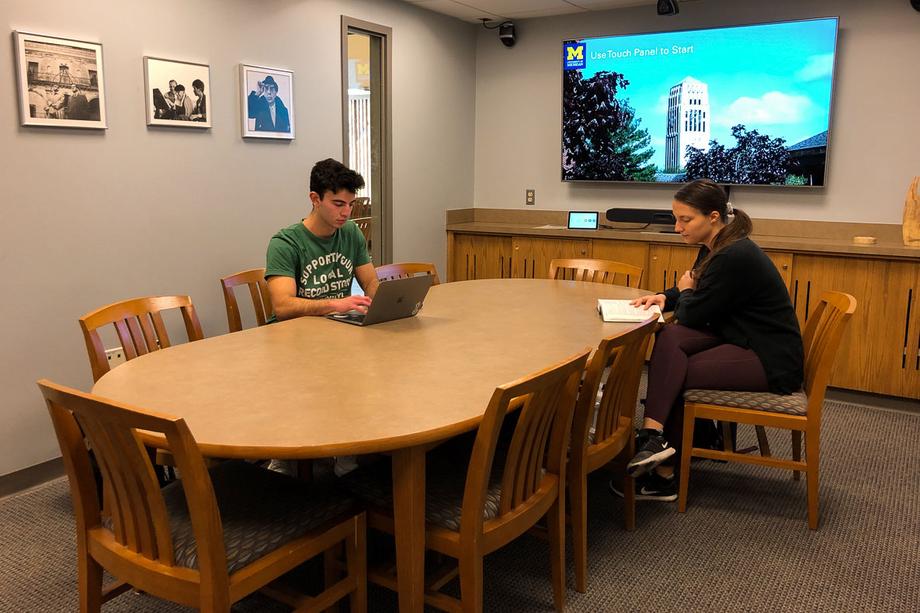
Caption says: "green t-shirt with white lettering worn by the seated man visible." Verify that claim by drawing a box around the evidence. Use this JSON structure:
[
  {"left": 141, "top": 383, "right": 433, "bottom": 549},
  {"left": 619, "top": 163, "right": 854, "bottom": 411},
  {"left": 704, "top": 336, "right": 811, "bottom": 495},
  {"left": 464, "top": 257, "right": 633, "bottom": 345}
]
[{"left": 265, "top": 221, "right": 371, "bottom": 300}]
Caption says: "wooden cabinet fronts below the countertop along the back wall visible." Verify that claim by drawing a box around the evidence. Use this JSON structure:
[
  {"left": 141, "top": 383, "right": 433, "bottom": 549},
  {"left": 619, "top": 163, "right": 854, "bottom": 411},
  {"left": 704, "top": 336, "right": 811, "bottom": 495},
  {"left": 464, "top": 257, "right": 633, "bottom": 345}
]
[{"left": 448, "top": 232, "right": 920, "bottom": 399}]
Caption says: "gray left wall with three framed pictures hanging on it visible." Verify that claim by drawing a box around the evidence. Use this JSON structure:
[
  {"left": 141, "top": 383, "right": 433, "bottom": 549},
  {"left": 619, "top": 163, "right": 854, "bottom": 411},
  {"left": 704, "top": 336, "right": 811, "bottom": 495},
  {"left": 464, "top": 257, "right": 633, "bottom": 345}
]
[{"left": 0, "top": 0, "right": 476, "bottom": 475}]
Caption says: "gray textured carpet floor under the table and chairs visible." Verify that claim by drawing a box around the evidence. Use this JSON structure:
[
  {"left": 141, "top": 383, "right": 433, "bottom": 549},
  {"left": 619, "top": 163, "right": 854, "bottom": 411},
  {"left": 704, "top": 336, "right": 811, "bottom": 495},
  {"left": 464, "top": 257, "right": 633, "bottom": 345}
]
[{"left": 0, "top": 394, "right": 920, "bottom": 613}]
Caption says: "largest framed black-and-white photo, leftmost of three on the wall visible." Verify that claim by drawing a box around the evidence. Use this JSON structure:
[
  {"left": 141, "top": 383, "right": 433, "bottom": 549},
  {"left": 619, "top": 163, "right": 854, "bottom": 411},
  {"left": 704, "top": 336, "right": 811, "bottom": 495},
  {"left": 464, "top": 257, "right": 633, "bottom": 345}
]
[{"left": 13, "top": 32, "right": 107, "bottom": 129}]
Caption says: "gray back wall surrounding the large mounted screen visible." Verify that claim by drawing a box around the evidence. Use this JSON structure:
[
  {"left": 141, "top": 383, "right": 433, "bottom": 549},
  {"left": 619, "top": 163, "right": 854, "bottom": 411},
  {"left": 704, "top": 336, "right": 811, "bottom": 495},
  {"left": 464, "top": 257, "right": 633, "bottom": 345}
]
[{"left": 475, "top": 0, "right": 920, "bottom": 224}]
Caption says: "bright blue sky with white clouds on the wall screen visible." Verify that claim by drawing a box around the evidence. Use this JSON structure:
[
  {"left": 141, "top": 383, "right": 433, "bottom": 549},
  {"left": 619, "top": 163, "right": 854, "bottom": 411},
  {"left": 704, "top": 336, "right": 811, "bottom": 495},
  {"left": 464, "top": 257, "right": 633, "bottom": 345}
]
[{"left": 581, "top": 18, "right": 837, "bottom": 168}]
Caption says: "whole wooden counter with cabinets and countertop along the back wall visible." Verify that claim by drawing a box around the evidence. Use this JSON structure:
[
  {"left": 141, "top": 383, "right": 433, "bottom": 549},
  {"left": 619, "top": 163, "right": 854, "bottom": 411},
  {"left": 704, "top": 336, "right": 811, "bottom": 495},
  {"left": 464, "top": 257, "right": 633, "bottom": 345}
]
[{"left": 447, "top": 209, "right": 920, "bottom": 399}]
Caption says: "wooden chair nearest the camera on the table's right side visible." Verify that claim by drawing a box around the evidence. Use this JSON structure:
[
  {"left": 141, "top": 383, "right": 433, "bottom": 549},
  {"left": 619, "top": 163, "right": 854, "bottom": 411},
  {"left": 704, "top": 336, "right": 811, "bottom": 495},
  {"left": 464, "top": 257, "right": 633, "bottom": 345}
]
[{"left": 346, "top": 351, "right": 588, "bottom": 611}]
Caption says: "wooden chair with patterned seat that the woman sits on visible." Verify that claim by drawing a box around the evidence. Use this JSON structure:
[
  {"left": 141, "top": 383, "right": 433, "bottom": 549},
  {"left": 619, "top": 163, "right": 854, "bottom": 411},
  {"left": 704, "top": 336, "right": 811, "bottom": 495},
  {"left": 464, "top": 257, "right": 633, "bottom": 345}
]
[{"left": 677, "top": 292, "right": 856, "bottom": 530}]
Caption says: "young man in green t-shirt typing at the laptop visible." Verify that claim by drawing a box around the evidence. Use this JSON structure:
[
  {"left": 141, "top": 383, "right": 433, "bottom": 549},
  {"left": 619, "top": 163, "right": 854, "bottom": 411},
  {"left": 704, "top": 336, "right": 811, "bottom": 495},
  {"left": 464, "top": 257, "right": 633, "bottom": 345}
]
[{"left": 265, "top": 158, "right": 378, "bottom": 321}]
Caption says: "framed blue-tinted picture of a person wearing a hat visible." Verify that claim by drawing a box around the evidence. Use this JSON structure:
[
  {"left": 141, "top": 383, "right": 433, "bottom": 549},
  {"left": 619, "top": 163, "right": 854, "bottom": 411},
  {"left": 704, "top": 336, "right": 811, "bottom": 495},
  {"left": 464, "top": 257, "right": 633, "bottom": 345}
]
[{"left": 240, "top": 64, "right": 294, "bottom": 140}]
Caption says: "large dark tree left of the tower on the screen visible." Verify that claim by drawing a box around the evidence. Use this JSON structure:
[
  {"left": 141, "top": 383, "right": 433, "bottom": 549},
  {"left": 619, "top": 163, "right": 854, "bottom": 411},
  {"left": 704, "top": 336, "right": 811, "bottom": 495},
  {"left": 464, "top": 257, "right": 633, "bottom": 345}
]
[{"left": 562, "top": 70, "right": 655, "bottom": 181}]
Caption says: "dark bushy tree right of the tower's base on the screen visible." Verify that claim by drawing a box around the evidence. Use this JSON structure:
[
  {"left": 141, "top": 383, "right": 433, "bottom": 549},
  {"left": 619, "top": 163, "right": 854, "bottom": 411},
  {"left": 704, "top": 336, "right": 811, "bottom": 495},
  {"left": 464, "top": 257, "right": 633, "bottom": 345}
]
[{"left": 685, "top": 124, "right": 791, "bottom": 185}]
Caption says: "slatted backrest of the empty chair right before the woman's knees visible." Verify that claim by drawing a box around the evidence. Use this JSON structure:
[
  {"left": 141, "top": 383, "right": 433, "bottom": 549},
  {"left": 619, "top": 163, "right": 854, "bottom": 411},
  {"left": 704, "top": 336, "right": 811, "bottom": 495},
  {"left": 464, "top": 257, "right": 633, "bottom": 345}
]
[{"left": 572, "top": 317, "right": 658, "bottom": 458}]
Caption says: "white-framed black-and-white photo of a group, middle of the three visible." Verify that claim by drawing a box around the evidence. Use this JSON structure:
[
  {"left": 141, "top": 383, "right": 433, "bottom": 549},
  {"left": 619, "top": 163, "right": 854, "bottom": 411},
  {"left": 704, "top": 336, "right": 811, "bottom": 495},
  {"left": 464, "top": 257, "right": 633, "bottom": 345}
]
[{"left": 144, "top": 56, "right": 211, "bottom": 128}]
